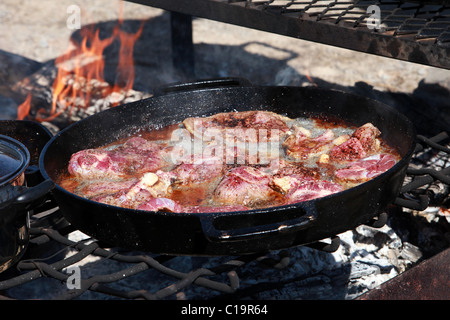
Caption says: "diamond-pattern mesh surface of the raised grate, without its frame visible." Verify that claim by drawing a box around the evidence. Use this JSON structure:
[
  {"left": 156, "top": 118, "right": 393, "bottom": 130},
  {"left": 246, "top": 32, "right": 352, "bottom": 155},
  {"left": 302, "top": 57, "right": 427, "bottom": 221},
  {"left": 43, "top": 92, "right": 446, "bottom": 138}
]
[{"left": 253, "top": 0, "right": 450, "bottom": 47}]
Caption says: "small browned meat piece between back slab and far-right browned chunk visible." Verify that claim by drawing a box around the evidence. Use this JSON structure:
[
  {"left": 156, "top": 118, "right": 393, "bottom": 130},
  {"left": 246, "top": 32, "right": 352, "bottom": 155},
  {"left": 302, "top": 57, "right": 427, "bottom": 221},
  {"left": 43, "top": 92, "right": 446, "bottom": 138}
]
[{"left": 283, "top": 129, "right": 334, "bottom": 160}]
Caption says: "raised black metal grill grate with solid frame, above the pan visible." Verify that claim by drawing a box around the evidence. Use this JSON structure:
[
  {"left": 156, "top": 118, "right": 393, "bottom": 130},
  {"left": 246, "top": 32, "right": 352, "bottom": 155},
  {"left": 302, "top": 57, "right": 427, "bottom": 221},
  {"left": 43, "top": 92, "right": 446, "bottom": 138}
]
[{"left": 129, "top": 0, "right": 450, "bottom": 69}]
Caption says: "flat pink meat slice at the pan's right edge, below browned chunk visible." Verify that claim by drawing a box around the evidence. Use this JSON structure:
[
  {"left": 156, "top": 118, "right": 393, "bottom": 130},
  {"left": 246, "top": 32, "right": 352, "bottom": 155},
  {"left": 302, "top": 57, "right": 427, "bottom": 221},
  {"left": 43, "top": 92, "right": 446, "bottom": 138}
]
[{"left": 335, "top": 154, "right": 397, "bottom": 183}]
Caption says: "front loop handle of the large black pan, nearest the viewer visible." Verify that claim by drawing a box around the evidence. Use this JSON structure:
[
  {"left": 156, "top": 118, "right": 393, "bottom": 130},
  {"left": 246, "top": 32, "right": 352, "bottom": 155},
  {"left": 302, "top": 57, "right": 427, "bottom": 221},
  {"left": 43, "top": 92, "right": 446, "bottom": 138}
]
[{"left": 200, "top": 201, "right": 318, "bottom": 242}]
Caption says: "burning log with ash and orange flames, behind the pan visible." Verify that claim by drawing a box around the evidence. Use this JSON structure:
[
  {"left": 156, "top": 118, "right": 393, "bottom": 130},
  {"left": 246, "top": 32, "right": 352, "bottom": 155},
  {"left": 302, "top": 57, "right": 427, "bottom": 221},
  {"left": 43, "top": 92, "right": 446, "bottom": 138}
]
[{"left": 13, "top": 20, "right": 150, "bottom": 131}]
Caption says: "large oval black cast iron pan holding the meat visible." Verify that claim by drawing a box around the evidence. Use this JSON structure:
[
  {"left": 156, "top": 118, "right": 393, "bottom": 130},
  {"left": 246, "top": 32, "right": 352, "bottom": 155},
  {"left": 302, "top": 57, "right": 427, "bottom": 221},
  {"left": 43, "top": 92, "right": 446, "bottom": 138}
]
[{"left": 39, "top": 78, "right": 416, "bottom": 255}]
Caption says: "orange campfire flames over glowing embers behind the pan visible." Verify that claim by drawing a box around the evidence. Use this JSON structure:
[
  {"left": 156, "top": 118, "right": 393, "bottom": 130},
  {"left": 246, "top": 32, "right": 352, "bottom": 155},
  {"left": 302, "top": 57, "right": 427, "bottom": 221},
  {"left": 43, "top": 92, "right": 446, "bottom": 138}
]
[{"left": 17, "top": 6, "right": 144, "bottom": 122}]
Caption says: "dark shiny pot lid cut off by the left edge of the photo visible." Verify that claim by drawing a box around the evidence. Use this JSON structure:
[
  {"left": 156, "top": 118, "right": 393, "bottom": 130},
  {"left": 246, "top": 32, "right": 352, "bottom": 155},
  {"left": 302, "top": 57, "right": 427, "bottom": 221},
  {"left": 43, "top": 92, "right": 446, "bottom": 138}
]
[{"left": 0, "top": 135, "right": 30, "bottom": 186}]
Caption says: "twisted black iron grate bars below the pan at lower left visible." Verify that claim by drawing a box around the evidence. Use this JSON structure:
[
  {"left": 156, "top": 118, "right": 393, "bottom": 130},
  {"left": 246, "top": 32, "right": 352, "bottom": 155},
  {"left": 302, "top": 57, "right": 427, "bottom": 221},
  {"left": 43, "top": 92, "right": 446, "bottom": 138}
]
[{"left": 0, "top": 228, "right": 260, "bottom": 300}]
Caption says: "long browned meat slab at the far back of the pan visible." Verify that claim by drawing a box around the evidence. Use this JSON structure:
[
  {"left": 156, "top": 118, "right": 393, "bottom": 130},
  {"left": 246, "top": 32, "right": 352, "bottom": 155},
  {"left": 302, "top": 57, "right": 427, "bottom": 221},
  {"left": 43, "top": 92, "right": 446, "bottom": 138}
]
[{"left": 183, "top": 111, "right": 290, "bottom": 142}]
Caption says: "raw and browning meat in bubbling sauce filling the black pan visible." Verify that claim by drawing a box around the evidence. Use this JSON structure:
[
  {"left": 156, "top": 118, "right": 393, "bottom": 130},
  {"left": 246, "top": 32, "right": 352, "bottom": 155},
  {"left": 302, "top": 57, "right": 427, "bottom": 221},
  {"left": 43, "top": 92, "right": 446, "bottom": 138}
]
[{"left": 58, "top": 111, "right": 400, "bottom": 212}]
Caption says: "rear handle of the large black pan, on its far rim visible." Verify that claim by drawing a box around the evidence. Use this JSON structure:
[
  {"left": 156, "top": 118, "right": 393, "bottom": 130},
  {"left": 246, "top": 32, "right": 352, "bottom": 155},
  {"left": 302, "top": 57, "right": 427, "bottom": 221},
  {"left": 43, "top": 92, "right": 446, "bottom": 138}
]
[{"left": 153, "top": 77, "right": 252, "bottom": 96}]
